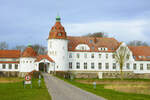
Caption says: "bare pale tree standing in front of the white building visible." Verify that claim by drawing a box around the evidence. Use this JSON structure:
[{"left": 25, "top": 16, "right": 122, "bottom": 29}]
[{"left": 114, "top": 45, "right": 130, "bottom": 80}]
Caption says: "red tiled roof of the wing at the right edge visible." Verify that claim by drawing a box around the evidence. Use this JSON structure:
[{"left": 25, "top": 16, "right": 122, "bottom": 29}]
[{"left": 128, "top": 46, "right": 150, "bottom": 61}]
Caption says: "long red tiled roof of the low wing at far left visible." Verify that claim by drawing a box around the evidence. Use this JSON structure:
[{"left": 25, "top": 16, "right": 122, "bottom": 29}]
[{"left": 0, "top": 50, "right": 21, "bottom": 58}]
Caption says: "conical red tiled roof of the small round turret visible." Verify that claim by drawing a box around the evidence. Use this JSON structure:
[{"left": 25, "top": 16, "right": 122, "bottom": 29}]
[{"left": 22, "top": 47, "right": 37, "bottom": 57}]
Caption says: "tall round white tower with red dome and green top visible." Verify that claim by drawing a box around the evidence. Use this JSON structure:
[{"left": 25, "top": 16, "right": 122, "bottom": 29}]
[{"left": 48, "top": 16, "right": 68, "bottom": 71}]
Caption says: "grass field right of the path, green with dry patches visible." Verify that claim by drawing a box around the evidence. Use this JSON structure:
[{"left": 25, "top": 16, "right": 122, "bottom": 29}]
[{"left": 58, "top": 79, "right": 150, "bottom": 100}]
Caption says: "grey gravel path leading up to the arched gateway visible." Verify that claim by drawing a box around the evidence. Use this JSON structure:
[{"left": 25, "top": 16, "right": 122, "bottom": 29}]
[{"left": 43, "top": 73, "right": 104, "bottom": 100}]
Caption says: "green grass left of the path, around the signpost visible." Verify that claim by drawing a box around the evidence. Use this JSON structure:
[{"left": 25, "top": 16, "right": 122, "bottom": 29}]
[{"left": 0, "top": 78, "right": 51, "bottom": 100}]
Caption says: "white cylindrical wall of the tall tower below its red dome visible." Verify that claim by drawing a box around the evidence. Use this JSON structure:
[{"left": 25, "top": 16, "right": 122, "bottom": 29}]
[{"left": 48, "top": 39, "right": 68, "bottom": 71}]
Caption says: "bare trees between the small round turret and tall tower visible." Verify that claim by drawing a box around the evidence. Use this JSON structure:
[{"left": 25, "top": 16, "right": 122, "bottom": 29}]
[{"left": 32, "top": 44, "right": 47, "bottom": 54}]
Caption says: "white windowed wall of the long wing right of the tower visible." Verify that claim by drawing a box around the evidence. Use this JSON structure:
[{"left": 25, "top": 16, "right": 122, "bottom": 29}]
[{"left": 68, "top": 52, "right": 150, "bottom": 73}]
